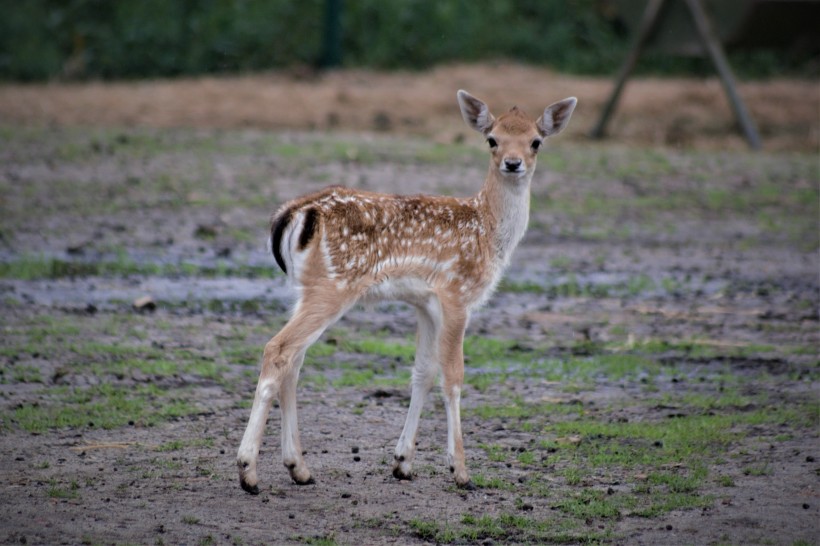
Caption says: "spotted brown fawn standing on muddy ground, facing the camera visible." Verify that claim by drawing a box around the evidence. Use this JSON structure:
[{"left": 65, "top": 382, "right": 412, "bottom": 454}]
[{"left": 236, "top": 90, "right": 577, "bottom": 494}]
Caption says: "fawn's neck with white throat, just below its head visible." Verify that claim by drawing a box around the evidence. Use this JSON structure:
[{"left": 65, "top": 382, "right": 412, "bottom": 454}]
[{"left": 478, "top": 166, "right": 532, "bottom": 265}]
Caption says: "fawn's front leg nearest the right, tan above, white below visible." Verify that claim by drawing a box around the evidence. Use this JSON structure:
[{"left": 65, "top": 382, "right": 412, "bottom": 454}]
[{"left": 440, "top": 309, "right": 472, "bottom": 489}]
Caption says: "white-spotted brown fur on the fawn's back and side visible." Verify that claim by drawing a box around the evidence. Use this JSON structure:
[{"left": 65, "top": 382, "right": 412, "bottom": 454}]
[{"left": 272, "top": 187, "right": 495, "bottom": 303}]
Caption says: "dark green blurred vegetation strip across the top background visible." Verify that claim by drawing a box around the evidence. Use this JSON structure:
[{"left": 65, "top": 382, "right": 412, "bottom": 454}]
[{"left": 0, "top": 0, "right": 816, "bottom": 81}]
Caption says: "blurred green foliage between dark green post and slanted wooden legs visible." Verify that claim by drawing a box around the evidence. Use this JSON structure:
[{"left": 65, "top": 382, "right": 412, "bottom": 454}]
[{"left": 344, "top": 0, "right": 628, "bottom": 73}]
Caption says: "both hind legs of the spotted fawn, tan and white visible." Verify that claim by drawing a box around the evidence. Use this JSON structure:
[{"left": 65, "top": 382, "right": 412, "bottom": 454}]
[{"left": 236, "top": 298, "right": 348, "bottom": 494}]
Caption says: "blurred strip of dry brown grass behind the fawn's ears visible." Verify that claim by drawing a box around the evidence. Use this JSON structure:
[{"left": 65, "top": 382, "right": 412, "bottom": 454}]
[{"left": 0, "top": 63, "right": 820, "bottom": 152}]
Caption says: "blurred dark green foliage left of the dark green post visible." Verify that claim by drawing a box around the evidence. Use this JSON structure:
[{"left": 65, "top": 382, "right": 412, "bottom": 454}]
[{"left": 0, "top": 0, "right": 324, "bottom": 80}]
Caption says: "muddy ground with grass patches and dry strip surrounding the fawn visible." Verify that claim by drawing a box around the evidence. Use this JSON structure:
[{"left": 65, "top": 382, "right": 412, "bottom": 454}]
[{"left": 0, "top": 65, "right": 820, "bottom": 546}]
